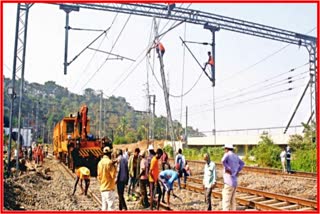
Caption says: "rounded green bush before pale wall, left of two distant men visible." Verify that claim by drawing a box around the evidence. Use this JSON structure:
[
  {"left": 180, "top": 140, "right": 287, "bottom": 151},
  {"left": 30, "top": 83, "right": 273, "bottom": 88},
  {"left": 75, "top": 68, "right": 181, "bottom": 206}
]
[{"left": 252, "top": 133, "right": 281, "bottom": 168}]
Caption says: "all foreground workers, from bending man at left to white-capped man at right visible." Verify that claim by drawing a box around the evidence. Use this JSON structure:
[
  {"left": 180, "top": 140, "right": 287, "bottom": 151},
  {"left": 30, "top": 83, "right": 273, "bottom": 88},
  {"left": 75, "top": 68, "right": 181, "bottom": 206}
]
[{"left": 73, "top": 144, "right": 244, "bottom": 211}]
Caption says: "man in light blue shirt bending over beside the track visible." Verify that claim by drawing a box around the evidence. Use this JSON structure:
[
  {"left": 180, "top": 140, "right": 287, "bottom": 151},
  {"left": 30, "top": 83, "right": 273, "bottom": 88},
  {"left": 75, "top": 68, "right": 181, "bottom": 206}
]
[{"left": 159, "top": 169, "right": 179, "bottom": 207}]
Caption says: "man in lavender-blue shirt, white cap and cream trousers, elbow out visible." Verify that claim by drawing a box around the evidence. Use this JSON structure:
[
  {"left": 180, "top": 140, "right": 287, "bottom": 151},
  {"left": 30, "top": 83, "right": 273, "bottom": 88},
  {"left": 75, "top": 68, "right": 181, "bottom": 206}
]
[{"left": 221, "top": 144, "right": 244, "bottom": 211}]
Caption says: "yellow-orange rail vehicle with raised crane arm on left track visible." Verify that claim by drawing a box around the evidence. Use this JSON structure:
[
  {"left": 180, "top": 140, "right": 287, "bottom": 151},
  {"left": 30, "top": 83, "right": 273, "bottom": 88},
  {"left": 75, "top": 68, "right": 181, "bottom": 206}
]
[{"left": 53, "top": 106, "right": 107, "bottom": 176}]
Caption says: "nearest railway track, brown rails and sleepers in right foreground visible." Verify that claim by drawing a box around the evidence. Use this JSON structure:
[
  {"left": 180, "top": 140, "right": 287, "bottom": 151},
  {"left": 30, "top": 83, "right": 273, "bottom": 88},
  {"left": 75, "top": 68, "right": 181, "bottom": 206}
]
[{"left": 184, "top": 177, "right": 317, "bottom": 211}]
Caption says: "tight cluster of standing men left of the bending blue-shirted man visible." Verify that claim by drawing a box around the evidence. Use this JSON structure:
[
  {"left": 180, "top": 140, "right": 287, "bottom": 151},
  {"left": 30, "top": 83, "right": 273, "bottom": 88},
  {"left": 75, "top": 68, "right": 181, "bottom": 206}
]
[{"left": 97, "top": 144, "right": 176, "bottom": 211}]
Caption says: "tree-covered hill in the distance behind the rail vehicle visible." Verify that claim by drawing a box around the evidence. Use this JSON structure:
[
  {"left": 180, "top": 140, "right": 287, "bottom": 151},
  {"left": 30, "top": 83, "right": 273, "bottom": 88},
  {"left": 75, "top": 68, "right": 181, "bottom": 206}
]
[{"left": 4, "top": 78, "right": 204, "bottom": 143}]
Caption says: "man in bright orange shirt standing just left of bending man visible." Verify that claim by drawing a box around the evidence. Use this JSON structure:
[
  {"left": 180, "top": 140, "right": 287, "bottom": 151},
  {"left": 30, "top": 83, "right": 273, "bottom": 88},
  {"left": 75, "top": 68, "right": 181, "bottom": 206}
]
[{"left": 149, "top": 149, "right": 163, "bottom": 210}]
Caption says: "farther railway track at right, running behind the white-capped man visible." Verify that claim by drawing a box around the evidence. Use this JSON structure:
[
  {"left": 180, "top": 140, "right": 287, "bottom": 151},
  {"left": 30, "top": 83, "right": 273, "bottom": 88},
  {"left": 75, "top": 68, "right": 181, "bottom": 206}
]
[{"left": 169, "top": 159, "right": 317, "bottom": 180}]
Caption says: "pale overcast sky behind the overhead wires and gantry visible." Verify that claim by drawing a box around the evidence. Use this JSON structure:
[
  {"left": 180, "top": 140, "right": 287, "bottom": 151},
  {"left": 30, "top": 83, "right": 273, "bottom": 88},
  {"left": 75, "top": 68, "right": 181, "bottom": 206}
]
[{"left": 3, "top": 3, "right": 317, "bottom": 134}]
